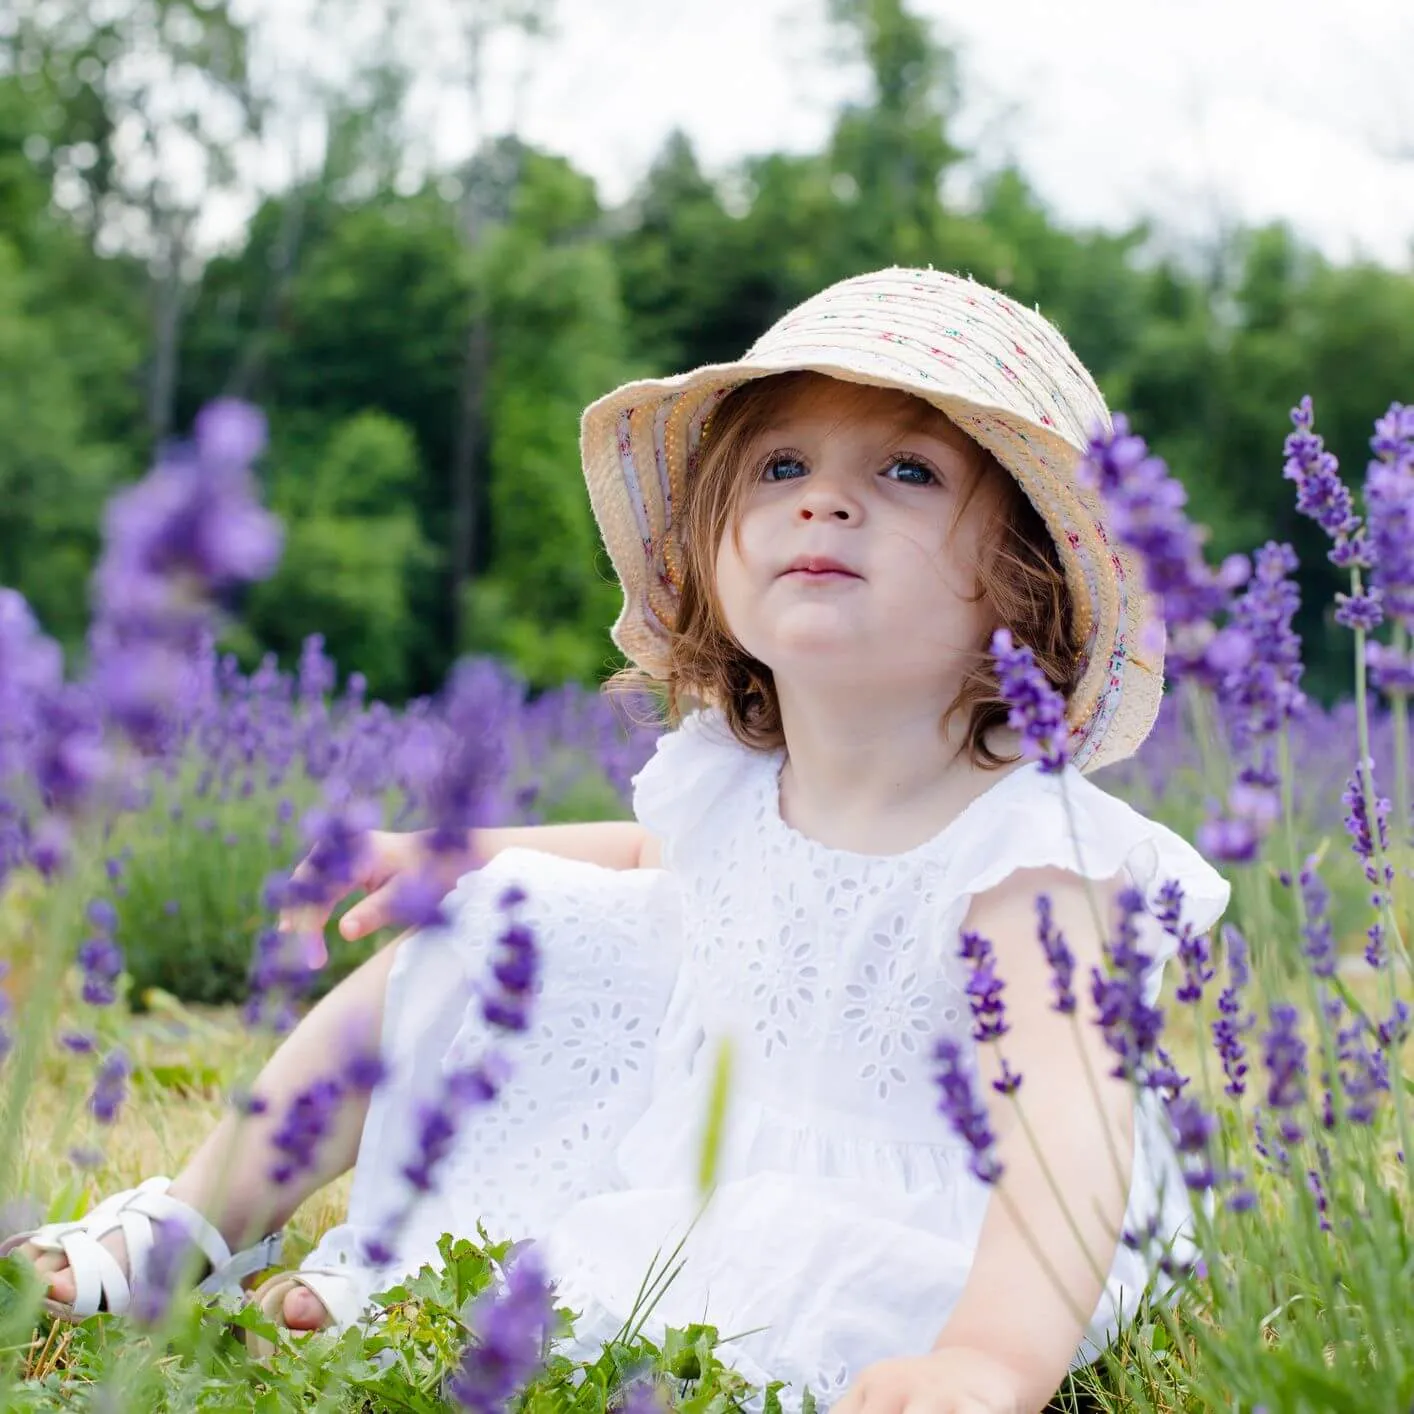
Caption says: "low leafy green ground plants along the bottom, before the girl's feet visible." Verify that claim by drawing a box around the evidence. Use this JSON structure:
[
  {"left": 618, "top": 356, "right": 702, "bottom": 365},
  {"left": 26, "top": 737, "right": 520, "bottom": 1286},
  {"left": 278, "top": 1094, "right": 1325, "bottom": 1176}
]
[{"left": 0, "top": 1233, "right": 782, "bottom": 1414}]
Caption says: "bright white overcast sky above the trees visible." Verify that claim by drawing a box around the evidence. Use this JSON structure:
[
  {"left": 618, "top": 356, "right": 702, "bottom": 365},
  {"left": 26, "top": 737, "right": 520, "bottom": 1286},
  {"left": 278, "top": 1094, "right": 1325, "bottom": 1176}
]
[{"left": 209, "top": 0, "right": 1414, "bottom": 269}]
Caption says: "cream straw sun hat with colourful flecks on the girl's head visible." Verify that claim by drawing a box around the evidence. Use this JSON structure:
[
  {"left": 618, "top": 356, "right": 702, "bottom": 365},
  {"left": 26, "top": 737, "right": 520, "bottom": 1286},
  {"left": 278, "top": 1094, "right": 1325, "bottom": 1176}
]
[{"left": 583, "top": 270, "right": 1162, "bottom": 771}]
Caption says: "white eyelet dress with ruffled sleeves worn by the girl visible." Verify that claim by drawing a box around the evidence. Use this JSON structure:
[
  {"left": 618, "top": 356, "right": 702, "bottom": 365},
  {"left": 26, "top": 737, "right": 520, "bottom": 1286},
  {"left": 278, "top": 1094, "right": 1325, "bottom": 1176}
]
[{"left": 307, "top": 713, "right": 1229, "bottom": 1404}]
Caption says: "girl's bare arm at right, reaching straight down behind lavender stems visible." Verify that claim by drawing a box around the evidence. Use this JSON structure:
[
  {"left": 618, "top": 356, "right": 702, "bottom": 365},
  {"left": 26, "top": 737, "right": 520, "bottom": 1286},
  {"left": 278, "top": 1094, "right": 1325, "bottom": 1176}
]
[{"left": 936, "top": 870, "right": 1134, "bottom": 1410}]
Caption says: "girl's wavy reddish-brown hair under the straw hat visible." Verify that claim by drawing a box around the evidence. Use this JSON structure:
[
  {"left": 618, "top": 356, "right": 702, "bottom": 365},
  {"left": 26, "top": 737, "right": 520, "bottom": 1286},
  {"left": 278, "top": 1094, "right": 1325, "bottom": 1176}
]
[{"left": 611, "top": 372, "right": 1083, "bottom": 769}]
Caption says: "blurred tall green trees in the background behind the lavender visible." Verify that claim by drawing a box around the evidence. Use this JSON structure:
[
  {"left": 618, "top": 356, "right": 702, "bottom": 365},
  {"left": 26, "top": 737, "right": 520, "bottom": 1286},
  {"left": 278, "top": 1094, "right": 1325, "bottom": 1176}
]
[{"left": 0, "top": 0, "right": 1414, "bottom": 697}]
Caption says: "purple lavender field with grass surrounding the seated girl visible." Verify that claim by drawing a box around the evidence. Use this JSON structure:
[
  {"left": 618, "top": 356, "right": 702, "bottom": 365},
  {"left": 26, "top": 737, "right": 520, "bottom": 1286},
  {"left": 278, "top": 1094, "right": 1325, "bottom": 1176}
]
[{"left": 0, "top": 403, "right": 1414, "bottom": 1414}]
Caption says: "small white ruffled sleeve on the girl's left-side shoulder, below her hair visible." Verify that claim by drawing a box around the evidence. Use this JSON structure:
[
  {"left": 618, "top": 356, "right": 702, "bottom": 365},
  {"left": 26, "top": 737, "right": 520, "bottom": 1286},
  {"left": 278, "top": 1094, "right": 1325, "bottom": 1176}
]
[{"left": 633, "top": 708, "right": 776, "bottom": 864}]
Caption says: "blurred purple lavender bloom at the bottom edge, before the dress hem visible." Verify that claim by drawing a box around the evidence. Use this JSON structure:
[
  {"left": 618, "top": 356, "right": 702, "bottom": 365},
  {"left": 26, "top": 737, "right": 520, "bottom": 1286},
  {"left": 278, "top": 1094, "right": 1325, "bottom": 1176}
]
[{"left": 447, "top": 1249, "right": 554, "bottom": 1414}]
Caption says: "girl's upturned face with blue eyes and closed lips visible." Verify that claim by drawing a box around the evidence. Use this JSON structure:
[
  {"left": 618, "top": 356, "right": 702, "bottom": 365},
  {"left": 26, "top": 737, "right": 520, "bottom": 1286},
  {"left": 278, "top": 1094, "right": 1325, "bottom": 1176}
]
[{"left": 715, "top": 376, "right": 994, "bottom": 710}]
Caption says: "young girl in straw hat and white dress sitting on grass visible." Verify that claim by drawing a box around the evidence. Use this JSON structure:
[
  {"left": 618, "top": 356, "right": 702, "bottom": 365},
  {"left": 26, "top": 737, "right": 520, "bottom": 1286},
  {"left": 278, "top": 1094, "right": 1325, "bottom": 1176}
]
[{"left": 8, "top": 270, "right": 1227, "bottom": 1414}]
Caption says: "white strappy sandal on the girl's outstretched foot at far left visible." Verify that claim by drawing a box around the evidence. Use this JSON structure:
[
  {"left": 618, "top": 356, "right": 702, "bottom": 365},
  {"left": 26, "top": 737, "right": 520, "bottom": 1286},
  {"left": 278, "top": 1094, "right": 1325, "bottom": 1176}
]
[{"left": 0, "top": 1178, "right": 284, "bottom": 1321}]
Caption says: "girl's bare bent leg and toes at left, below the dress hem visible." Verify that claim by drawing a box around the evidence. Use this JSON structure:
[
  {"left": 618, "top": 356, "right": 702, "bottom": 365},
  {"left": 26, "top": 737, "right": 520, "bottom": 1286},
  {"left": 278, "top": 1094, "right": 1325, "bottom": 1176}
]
[{"left": 28, "top": 935, "right": 406, "bottom": 1325}]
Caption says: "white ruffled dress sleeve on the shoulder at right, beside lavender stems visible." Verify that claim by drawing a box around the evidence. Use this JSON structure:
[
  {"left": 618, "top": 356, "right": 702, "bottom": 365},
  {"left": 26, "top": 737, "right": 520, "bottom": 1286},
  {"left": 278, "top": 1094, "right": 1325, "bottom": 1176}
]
[{"left": 947, "top": 766, "right": 1232, "bottom": 991}]
